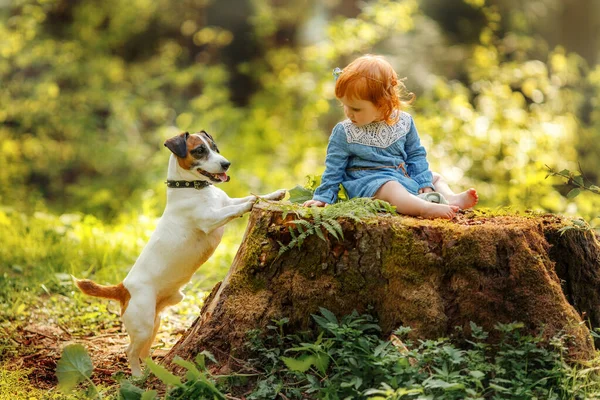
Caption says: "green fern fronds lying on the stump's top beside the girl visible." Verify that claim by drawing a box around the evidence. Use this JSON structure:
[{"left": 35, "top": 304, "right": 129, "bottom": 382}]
[{"left": 278, "top": 198, "right": 396, "bottom": 256}]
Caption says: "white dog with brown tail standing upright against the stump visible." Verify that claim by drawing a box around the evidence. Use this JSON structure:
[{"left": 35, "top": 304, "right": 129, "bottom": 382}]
[{"left": 75, "top": 131, "right": 285, "bottom": 376}]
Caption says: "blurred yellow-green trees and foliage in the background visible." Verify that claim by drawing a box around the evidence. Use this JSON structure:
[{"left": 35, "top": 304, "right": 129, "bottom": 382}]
[{"left": 0, "top": 0, "right": 600, "bottom": 219}]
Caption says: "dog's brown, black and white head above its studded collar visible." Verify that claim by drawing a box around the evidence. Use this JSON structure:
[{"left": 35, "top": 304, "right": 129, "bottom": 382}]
[{"left": 165, "top": 131, "right": 231, "bottom": 183}]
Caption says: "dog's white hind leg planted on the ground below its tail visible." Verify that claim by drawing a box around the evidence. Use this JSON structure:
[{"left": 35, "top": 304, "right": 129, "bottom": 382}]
[{"left": 122, "top": 293, "right": 156, "bottom": 376}]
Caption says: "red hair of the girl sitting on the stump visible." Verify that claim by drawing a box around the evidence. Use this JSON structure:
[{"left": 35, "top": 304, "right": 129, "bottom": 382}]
[{"left": 335, "top": 54, "right": 415, "bottom": 125}]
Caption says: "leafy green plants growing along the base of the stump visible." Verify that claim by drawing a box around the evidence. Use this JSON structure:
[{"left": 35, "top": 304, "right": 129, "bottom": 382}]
[{"left": 241, "top": 309, "right": 600, "bottom": 400}]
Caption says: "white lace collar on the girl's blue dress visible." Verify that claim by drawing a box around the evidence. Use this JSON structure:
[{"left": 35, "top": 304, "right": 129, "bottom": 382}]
[{"left": 341, "top": 111, "right": 411, "bottom": 149}]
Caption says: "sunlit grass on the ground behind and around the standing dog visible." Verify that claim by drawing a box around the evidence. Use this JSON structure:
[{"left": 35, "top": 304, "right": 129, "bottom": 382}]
[{"left": 0, "top": 199, "right": 246, "bottom": 400}]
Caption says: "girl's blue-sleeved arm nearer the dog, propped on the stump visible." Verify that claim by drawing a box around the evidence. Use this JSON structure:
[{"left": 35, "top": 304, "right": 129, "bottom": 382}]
[{"left": 312, "top": 124, "right": 350, "bottom": 204}]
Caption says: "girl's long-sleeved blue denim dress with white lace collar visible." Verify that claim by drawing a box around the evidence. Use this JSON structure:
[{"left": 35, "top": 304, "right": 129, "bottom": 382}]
[{"left": 313, "top": 112, "right": 433, "bottom": 204}]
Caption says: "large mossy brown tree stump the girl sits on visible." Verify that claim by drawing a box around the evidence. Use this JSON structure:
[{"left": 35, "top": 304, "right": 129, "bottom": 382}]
[{"left": 165, "top": 203, "right": 600, "bottom": 368}]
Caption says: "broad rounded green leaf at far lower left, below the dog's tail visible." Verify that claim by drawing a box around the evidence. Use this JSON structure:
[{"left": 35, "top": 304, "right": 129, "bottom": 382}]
[{"left": 56, "top": 344, "right": 94, "bottom": 391}]
